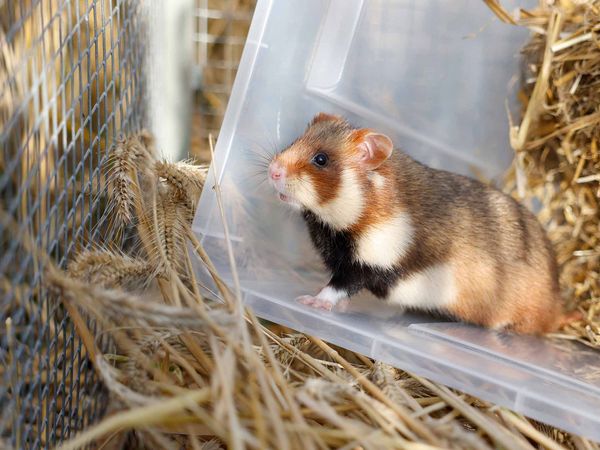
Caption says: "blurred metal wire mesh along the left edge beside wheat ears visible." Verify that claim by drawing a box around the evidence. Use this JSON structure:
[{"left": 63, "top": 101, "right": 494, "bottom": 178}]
[{"left": 0, "top": 0, "right": 147, "bottom": 448}]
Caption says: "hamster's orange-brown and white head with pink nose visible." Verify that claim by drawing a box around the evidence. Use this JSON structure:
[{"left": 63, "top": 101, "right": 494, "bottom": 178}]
[{"left": 268, "top": 113, "right": 393, "bottom": 229}]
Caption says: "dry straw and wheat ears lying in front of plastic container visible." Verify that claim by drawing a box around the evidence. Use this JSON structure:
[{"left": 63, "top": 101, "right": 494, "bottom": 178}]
[{"left": 32, "top": 131, "right": 599, "bottom": 449}]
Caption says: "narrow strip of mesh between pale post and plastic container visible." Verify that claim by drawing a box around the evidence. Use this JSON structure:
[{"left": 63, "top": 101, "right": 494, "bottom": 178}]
[{"left": 191, "top": 0, "right": 256, "bottom": 160}]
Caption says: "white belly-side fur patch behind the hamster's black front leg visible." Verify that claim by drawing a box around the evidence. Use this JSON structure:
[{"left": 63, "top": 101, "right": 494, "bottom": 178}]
[{"left": 388, "top": 264, "right": 457, "bottom": 310}]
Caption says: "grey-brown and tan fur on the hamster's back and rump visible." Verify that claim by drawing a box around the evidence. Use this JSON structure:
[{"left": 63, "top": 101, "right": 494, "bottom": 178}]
[{"left": 389, "top": 152, "right": 562, "bottom": 333}]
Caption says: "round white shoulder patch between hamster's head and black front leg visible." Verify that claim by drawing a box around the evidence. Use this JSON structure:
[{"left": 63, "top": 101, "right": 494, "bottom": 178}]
[{"left": 356, "top": 213, "right": 414, "bottom": 268}]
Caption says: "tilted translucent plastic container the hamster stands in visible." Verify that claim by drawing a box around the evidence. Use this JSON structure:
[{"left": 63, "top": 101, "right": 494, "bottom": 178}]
[{"left": 194, "top": 0, "right": 600, "bottom": 440}]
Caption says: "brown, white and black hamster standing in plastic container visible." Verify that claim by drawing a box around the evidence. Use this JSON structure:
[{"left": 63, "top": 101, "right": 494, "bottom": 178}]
[{"left": 268, "top": 113, "right": 568, "bottom": 334}]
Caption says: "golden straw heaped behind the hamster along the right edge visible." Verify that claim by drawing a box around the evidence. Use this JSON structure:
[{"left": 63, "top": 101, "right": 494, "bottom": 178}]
[{"left": 492, "top": 0, "right": 600, "bottom": 348}]
